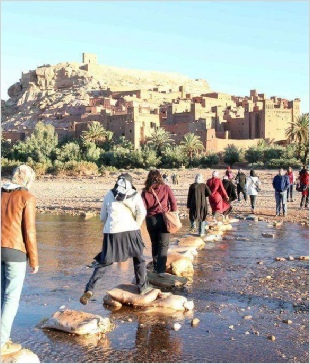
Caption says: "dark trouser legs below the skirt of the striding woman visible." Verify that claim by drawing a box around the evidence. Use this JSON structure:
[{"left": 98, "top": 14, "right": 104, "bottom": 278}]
[{"left": 85, "top": 255, "right": 147, "bottom": 293}]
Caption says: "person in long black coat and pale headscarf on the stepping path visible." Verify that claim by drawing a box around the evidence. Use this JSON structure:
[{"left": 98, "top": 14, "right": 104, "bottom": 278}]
[{"left": 187, "top": 173, "right": 211, "bottom": 236}]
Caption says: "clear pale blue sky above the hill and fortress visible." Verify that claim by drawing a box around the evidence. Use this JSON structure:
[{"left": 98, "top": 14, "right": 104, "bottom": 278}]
[{"left": 1, "top": 0, "right": 309, "bottom": 112}]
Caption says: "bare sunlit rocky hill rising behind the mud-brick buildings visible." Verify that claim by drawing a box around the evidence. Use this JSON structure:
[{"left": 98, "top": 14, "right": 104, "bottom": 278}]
[{"left": 1, "top": 62, "right": 211, "bottom": 130}]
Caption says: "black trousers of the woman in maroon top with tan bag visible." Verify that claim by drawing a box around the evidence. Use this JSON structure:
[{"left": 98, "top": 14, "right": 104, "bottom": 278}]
[{"left": 145, "top": 214, "right": 170, "bottom": 273}]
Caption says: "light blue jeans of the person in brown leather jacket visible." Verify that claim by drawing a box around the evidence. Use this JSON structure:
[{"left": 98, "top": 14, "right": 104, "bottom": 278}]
[{"left": 1, "top": 262, "right": 27, "bottom": 346}]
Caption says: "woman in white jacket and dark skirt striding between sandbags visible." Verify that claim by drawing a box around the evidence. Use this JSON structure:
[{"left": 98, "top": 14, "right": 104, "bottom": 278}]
[{"left": 80, "top": 173, "right": 150, "bottom": 305}]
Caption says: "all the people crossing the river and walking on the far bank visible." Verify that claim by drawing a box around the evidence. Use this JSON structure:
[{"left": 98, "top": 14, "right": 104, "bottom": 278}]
[{"left": 1, "top": 165, "right": 309, "bottom": 355}]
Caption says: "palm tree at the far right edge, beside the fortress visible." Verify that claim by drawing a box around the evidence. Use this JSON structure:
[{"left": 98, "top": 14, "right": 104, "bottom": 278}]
[{"left": 285, "top": 114, "right": 309, "bottom": 161}]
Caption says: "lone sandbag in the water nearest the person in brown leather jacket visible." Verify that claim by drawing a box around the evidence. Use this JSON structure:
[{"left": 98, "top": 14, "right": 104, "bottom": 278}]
[{"left": 42, "top": 309, "right": 113, "bottom": 335}]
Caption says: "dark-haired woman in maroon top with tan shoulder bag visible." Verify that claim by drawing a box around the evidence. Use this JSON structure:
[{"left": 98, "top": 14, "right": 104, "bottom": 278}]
[{"left": 142, "top": 169, "right": 178, "bottom": 276}]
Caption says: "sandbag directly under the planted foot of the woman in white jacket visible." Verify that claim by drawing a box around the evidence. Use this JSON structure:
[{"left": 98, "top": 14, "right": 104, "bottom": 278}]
[{"left": 107, "top": 284, "right": 160, "bottom": 306}]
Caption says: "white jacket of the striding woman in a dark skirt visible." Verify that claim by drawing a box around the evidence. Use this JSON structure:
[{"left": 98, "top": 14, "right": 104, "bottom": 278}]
[{"left": 100, "top": 189, "right": 146, "bottom": 233}]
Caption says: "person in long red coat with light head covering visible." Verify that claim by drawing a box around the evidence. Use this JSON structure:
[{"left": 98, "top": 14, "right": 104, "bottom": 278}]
[{"left": 206, "top": 171, "right": 232, "bottom": 220}]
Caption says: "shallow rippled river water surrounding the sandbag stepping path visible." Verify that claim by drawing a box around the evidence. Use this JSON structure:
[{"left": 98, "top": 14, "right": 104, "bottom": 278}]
[{"left": 12, "top": 215, "right": 309, "bottom": 363}]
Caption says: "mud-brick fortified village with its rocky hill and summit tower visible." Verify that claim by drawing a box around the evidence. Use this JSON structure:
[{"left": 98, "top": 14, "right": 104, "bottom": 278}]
[{"left": 1, "top": 53, "right": 300, "bottom": 152}]
